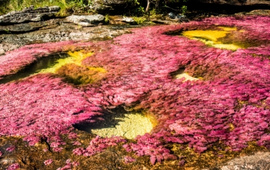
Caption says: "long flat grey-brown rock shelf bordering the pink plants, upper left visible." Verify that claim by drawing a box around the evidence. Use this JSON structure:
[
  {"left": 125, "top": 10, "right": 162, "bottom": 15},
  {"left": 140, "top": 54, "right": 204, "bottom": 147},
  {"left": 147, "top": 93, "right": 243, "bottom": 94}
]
[{"left": 0, "top": 19, "right": 130, "bottom": 56}]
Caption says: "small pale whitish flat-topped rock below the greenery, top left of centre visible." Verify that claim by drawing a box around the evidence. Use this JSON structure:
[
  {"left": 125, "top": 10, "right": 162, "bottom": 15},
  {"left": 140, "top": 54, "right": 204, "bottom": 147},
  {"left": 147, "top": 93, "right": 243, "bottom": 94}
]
[{"left": 66, "top": 14, "right": 105, "bottom": 27}]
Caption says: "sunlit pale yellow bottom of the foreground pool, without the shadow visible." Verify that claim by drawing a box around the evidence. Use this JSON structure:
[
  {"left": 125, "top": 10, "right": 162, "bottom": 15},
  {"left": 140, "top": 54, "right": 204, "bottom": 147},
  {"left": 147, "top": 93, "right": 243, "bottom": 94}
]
[{"left": 91, "top": 113, "right": 154, "bottom": 139}]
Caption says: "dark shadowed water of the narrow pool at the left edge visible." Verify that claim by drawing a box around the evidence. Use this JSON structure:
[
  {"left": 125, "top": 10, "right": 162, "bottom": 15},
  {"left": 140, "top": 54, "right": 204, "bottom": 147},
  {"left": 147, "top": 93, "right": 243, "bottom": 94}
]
[{"left": 0, "top": 53, "right": 69, "bottom": 84}]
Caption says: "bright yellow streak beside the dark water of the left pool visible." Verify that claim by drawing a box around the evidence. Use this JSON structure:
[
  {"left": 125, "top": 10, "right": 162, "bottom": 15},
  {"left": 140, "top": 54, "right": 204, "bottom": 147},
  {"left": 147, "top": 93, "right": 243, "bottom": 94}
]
[{"left": 39, "top": 50, "right": 93, "bottom": 73}]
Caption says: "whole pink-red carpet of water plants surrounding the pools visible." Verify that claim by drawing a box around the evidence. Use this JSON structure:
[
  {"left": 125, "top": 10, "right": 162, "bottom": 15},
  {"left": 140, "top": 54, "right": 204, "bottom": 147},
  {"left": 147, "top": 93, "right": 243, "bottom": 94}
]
[{"left": 0, "top": 16, "right": 270, "bottom": 167}]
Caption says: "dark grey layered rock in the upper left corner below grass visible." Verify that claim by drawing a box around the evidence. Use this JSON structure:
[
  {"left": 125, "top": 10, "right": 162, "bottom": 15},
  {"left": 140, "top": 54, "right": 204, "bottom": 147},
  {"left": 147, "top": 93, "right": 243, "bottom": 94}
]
[{"left": 0, "top": 6, "right": 60, "bottom": 25}]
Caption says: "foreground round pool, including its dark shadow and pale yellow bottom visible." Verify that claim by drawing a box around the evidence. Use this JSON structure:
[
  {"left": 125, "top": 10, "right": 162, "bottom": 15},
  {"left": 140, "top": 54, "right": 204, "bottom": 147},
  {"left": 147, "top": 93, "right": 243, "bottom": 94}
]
[{"left": 74, "top": 107, "right": 155, "bottom": 139}]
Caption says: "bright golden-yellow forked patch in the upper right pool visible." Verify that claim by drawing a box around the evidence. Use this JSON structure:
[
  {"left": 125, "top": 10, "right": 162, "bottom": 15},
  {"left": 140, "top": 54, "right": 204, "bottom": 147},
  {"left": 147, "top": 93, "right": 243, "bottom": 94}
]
[{"left": 182, "top": 26, "right": 241, "bottom": 50}]
